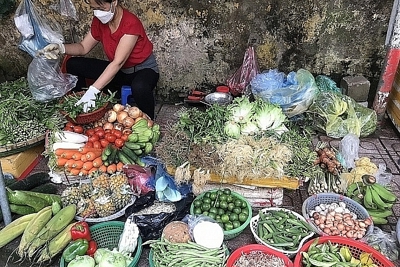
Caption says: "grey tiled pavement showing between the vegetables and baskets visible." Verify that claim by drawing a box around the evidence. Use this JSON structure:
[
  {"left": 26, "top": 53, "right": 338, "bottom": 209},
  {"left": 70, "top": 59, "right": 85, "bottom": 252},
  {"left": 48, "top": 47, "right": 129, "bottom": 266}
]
[{"left": 0, "top": 104, "right": 400, "bottom": 267}]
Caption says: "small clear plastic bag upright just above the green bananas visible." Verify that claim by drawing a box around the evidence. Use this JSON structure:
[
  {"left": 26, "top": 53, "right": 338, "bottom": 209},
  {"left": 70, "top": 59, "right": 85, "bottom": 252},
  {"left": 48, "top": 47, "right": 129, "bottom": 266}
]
[{"left": 339, "top": 133, "right": 360, "bottom": 169}]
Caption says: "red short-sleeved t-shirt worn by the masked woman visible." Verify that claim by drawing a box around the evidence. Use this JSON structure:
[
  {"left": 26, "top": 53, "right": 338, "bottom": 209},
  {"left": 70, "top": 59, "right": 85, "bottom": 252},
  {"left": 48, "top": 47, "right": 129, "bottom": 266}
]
[{"left": 91, "top": 9, "right": 153, "bottom": 68}]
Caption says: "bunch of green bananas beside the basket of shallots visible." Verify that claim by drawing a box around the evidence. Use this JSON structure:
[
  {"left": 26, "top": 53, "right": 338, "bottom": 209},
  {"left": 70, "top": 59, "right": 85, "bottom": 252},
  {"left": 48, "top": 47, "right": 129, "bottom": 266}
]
[{"left": 346, "top": 175, "right": 397, "bottom": 224}]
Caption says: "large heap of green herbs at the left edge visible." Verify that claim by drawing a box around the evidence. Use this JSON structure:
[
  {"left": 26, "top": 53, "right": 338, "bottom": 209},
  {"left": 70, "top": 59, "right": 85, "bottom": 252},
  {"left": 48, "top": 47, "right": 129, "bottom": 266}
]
[{"left": 0, "top": 77, "right": 64, "bottom": 146}]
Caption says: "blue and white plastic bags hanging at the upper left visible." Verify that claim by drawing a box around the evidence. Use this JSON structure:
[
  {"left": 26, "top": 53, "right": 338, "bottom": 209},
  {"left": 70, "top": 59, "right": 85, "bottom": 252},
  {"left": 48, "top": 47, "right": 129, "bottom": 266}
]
[{"left": 14, "top": 0, "right": 64, "bottom": 57}]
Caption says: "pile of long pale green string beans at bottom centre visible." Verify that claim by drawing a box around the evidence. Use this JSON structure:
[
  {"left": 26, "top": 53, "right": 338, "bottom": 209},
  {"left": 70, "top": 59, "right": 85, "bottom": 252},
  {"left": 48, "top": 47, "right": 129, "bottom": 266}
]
[{"left": 143, "top": 238, "right": 227, "bottom": 267}]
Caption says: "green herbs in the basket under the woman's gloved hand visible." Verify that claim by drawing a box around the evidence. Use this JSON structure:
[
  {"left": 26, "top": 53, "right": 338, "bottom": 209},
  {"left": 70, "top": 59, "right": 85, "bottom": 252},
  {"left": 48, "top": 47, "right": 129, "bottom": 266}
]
[{"left": 58, "top": 91, "right": 117, "bottom": 119}]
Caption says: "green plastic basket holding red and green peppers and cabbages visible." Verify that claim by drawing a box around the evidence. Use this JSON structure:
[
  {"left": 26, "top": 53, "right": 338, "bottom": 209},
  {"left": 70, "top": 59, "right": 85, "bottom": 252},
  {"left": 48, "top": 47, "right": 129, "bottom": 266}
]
[{"left": 60, "top": 221, "right": 142, "bottom": 267}]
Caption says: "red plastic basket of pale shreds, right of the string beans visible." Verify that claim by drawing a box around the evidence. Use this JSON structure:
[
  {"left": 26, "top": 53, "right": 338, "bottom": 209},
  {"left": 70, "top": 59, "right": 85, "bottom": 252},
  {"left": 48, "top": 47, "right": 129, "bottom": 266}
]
[{"left": 226, "top": 244, "right": 294, "bottom": 267}]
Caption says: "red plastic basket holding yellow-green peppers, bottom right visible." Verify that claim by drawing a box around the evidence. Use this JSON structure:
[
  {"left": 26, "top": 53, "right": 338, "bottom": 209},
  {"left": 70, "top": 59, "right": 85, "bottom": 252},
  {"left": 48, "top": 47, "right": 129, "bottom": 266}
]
[{"left": 294, "top": 236, "right": 395, "bottom": 267}]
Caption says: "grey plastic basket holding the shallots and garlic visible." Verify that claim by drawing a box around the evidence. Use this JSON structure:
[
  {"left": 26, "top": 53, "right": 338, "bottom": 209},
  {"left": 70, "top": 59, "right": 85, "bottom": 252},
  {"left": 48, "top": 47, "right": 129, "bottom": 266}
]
[{"left": 302, "top": 193, "right": 374, "bottom": 240}]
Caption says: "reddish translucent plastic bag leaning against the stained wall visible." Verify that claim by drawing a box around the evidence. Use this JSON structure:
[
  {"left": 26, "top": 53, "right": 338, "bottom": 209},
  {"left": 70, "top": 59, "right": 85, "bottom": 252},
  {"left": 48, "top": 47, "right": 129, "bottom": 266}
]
[{"left": 226, "top": 46, "right": 260, "bottom": 96}]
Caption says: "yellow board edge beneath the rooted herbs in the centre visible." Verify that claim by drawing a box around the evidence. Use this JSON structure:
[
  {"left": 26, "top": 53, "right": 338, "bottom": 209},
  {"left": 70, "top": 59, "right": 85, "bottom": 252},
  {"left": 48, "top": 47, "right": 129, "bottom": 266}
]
[{"left": 167, "top": 166, "right": 300, "bottom": 190}]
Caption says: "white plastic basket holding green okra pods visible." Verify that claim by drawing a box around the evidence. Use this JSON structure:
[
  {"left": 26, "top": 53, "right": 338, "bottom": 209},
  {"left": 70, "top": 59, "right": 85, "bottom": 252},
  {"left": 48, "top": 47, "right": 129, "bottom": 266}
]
[{"left": 250, "top": 208, "right": 315, "bottom": 258}]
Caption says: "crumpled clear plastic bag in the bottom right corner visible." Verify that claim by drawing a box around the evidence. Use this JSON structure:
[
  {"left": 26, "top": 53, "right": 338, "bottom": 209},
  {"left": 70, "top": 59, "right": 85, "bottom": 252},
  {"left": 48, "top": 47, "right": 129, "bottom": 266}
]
[{"left": 362, "top": 227, "right": 399, "bottom": 262}]
